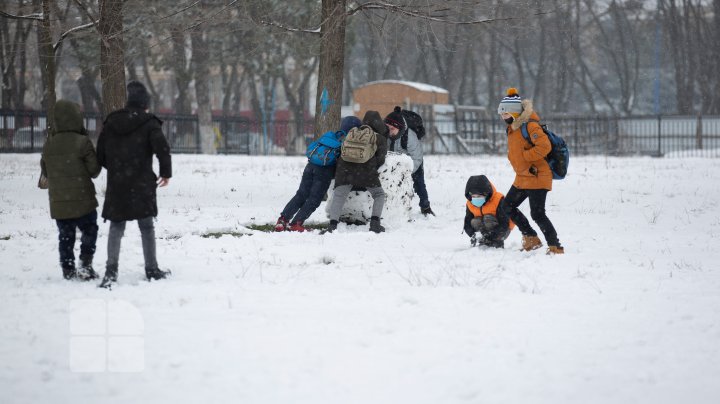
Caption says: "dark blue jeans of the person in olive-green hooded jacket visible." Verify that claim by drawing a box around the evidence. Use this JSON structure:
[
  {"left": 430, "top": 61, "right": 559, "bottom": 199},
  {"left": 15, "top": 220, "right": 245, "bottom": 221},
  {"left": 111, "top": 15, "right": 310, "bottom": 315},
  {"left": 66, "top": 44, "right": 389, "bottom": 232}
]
[{"left": 55, "top": 210, "right": 98, "bottom": 268}]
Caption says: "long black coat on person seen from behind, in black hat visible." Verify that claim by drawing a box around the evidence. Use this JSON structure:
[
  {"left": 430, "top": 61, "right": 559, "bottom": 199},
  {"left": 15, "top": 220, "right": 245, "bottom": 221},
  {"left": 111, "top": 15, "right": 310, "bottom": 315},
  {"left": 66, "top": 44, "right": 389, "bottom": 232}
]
[{"left": 98, "top": 108, "right": 172, "bottom": 222}]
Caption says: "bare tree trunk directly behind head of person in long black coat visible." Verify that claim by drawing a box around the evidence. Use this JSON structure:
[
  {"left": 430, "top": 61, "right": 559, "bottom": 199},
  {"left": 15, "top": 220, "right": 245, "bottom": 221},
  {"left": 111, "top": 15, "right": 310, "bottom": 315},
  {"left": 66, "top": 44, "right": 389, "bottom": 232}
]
[{"left": 100, "top": 0, "right": 126, "bottom": 116}]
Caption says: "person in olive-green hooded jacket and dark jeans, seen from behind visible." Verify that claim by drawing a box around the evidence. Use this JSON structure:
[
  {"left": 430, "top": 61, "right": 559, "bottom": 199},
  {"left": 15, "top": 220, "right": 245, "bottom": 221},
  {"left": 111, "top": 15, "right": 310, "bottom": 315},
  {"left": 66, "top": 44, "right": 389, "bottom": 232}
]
[{"left": 40, "top": 100, "right": 101, "bottom": 280}]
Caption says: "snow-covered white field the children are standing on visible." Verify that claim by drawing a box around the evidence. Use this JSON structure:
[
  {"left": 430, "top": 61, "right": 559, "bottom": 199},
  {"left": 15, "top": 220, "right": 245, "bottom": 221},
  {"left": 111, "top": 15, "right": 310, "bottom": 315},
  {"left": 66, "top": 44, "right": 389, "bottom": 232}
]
[{"left": 0, "top": 154, "right": 720, "bottom": 404}]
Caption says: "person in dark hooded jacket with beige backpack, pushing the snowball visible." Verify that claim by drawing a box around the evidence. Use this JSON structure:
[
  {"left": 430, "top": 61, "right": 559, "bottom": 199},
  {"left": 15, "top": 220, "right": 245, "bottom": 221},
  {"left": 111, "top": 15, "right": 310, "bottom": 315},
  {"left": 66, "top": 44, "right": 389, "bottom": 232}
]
[{"left": 327, "top": 111, "right": 390, "bottom": 233}]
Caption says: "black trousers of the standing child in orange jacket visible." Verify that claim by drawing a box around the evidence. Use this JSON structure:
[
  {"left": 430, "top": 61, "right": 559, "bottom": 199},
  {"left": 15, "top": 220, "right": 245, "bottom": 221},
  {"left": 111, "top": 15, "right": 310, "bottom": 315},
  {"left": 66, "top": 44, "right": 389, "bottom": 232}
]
[{"left": 503, "top": 185, "right": 560, "bottom": 247}]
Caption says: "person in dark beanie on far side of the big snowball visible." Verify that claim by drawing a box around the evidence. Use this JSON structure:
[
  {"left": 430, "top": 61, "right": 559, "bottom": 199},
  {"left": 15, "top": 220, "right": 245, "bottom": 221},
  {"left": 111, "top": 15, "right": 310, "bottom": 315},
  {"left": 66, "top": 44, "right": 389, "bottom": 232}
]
[{"left": 385, "top": 106, "right": 435, "bottom": 216}]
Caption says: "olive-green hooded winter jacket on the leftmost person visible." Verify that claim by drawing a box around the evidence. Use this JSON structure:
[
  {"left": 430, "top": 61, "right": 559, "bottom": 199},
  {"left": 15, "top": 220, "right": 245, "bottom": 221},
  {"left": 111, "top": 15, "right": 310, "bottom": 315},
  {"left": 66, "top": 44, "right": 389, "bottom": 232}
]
[{"left": 40, "top": 100, "right": 101, "bottom": 219}]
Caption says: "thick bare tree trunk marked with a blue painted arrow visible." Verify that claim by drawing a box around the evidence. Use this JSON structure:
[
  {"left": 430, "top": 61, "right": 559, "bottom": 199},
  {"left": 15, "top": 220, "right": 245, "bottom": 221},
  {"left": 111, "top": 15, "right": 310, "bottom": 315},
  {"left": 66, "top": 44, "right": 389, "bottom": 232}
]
[{"left": 315, "top": 0, "right": 347, "bottom": 134}]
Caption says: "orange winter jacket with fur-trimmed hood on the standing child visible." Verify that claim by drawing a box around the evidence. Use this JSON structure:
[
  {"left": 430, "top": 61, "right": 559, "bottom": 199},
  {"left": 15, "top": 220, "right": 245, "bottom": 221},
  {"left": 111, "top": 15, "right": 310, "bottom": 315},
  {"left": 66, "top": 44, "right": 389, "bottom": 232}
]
[{"left": 508, "top": 100, "right": 552, "bottom": 191}]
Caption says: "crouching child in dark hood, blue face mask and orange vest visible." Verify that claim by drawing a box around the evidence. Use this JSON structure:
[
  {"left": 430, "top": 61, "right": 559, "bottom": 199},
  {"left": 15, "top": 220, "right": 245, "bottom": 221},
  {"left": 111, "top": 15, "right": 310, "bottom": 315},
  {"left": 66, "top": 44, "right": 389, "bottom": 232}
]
[{"left": 463, "top": 175, "right": 515, "bottom": 248}]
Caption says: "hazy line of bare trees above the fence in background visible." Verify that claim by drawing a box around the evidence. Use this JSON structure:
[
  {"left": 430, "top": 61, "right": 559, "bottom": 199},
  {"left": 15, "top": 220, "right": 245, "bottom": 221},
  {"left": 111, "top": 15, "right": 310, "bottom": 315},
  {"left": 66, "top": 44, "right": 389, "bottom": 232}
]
[{"left": 0, "top": 0, "right": 720, "bottom": 147}]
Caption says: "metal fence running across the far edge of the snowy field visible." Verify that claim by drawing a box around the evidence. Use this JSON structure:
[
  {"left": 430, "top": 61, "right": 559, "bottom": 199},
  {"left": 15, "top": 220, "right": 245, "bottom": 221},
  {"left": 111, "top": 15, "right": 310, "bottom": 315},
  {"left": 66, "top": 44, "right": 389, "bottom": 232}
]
[{"left": 0, "top": 111, "right": 720, "bottom": 157}]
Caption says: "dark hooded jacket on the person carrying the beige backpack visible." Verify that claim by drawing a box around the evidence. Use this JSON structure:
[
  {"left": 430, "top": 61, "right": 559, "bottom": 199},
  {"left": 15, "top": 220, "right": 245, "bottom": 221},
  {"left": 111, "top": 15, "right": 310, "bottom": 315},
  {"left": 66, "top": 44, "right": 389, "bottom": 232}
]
[{"left": 335, "top": 111, "right": 388, "bottom": 188}]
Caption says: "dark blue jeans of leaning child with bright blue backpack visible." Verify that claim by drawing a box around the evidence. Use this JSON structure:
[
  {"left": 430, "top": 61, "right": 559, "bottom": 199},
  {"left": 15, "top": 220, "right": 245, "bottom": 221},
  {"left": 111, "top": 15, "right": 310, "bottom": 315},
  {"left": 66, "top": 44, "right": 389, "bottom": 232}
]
[{"left": 280, "top": 163, "right": 335, "bottom": 223}]
